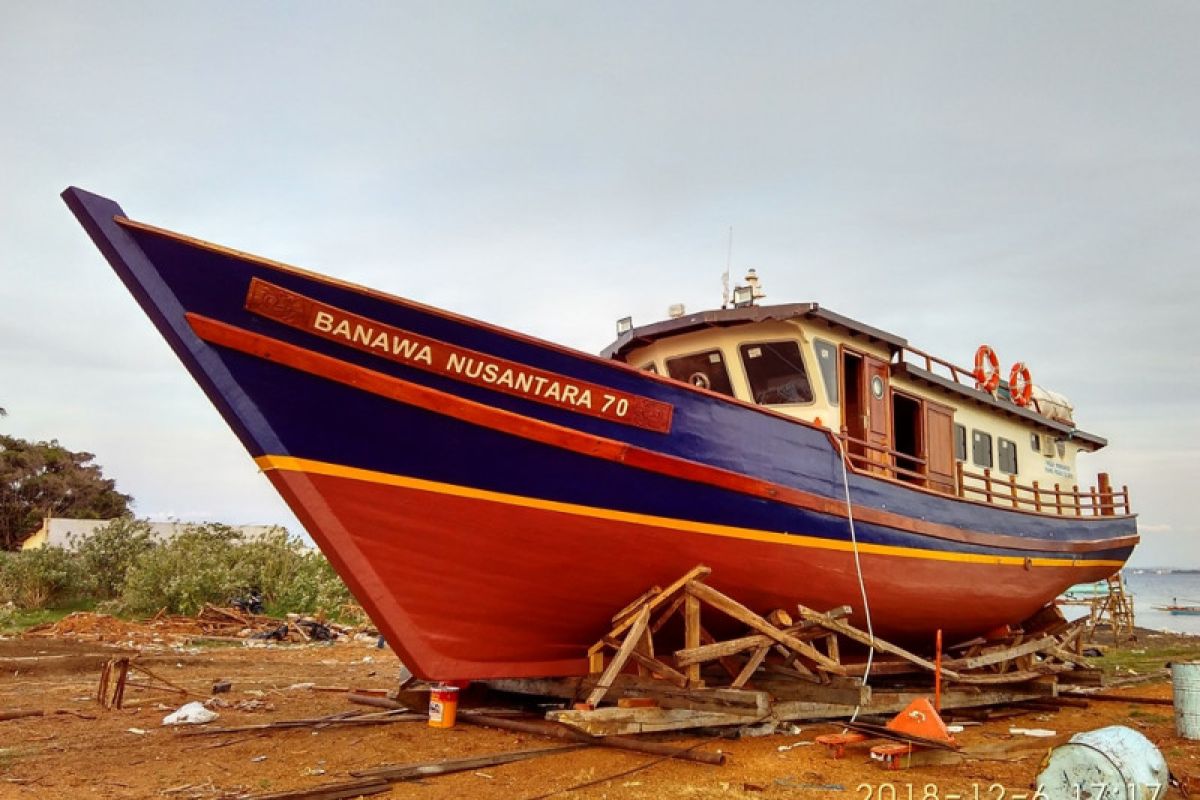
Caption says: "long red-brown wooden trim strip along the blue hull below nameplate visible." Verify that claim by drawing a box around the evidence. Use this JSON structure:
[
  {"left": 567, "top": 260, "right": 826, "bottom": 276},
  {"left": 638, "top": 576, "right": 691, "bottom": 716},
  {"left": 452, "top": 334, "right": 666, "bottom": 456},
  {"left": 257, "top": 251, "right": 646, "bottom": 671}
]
[{"left": 186, "top": 313, "right": 1139, "bottom": 553}]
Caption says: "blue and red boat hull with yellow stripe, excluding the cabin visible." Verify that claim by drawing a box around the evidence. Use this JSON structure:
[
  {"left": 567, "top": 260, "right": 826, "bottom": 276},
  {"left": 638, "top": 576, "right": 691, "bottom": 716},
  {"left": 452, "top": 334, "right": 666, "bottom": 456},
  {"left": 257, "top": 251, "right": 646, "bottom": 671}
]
[{"left": 65, "top": 190, "right": 1136, "bottom": 679}]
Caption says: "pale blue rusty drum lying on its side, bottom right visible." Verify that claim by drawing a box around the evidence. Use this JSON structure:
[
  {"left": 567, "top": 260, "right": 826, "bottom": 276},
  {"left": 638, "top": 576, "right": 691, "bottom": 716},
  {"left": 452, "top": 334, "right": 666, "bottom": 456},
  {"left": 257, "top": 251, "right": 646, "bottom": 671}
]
[{"left": 1037, "top": 726, "right": 1170, "bottom": 800}]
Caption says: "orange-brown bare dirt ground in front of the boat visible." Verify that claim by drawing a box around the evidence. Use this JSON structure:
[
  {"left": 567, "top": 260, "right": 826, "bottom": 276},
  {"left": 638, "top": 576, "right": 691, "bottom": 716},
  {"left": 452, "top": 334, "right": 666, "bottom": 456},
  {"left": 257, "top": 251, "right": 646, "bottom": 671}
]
[{"left": 0, "top": 636, "right": 1200, "bottom": 800}]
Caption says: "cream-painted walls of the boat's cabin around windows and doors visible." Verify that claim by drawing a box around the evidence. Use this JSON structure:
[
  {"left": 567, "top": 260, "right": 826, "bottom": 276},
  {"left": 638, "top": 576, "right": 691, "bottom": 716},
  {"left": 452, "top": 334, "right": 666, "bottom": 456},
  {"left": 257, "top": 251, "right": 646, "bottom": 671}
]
[{"left": 629, "top": 320, "right": 1094, "bottom": 489}]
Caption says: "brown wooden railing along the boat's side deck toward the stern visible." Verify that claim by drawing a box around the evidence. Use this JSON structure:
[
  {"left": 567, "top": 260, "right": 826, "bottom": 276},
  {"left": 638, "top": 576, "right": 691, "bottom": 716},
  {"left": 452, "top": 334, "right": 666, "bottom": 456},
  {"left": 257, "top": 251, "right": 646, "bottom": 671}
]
[{"left": 838, "top": 428, "right": 1130, "bottom": 517}]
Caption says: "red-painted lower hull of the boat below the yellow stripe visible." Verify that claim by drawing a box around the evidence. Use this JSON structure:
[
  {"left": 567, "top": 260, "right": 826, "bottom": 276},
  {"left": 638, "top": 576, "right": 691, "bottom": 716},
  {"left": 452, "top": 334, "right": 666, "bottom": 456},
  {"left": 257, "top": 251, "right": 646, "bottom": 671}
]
[{"left": 268, "top": 469, "right": 1112, "bottom": 680}]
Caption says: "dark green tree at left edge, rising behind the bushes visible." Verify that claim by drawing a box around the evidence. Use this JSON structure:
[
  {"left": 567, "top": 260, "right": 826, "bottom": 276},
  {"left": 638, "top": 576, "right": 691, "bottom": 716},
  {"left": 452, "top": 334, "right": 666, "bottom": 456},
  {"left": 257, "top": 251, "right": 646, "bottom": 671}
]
[{"left": 0, "top": 434, "right": 133, "bottom": 551}]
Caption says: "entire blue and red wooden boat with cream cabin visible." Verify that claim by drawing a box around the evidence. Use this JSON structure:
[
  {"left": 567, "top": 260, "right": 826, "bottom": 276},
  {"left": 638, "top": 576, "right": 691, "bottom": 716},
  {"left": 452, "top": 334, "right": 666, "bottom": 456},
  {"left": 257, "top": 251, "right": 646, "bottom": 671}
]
[{"left": 64, "top": 188, "right": 1138, "bottom": 679}]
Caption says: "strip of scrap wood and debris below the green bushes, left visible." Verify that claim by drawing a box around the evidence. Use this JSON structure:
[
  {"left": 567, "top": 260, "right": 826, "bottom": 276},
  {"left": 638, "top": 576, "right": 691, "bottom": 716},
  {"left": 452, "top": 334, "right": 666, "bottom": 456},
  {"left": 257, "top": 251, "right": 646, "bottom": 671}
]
[{"left": 23, "top": 604, "right": 378, "bottom": 643}]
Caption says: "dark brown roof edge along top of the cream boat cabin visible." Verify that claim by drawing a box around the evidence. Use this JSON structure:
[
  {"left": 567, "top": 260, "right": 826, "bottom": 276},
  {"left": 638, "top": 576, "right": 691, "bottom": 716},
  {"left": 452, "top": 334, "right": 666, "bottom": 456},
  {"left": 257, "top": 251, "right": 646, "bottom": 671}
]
[{"left": 600, "top": 302, "right": 1108, "bottom": 450}]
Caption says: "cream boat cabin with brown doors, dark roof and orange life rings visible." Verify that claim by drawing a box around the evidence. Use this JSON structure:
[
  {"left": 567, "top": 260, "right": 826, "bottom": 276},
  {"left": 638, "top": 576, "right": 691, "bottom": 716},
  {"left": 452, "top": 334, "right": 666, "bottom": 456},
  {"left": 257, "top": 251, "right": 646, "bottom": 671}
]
[{"left": 604, "top": 287, "right": 1129, "bottom": 516}]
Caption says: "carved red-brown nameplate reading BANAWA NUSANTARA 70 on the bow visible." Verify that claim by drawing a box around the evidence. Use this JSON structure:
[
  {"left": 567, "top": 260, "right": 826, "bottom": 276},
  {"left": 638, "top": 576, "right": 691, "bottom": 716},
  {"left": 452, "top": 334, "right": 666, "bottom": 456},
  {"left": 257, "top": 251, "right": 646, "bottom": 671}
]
[{"left": 246, "top": 278, "right": 673, "bottom": 433}]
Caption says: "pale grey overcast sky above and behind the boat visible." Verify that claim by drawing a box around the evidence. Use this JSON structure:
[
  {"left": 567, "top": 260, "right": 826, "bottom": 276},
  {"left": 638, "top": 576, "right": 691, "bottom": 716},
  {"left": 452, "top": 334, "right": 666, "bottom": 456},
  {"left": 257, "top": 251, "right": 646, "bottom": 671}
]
[{"left": 0, "top": 0, "right": 1200, "bottom": 566}]
